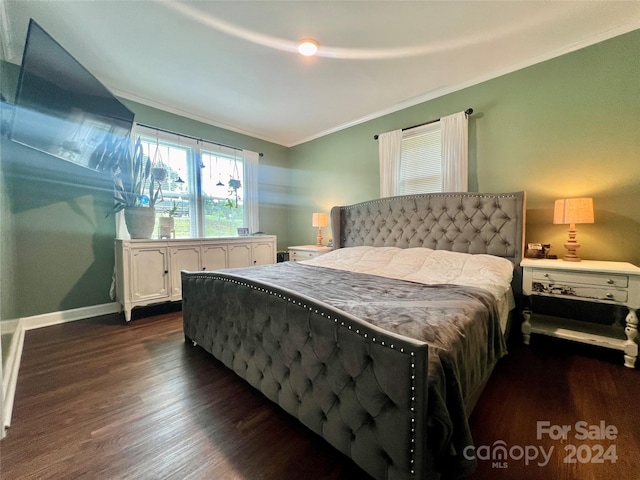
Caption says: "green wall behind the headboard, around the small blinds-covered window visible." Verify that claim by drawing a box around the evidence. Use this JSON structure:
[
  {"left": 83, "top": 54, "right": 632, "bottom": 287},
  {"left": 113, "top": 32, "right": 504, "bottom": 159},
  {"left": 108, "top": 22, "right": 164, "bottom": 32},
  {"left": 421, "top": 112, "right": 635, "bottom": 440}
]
[{"left": 290, "top": 30, "right": 640, "bottom": 265}]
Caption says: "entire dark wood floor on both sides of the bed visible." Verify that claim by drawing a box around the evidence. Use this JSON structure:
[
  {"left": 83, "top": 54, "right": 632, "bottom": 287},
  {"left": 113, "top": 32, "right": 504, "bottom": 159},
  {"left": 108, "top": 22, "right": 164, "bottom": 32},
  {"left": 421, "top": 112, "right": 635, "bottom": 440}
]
[{"left": 0, "top": 312, "right": 640, "bottom": 480}]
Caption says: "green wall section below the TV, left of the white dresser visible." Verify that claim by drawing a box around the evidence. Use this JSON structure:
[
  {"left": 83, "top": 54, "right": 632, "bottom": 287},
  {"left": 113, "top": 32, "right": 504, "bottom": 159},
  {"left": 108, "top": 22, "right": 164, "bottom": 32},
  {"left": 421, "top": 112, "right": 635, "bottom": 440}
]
[{"left": 2, "top": 139, "right": 115, "bottom": 317}]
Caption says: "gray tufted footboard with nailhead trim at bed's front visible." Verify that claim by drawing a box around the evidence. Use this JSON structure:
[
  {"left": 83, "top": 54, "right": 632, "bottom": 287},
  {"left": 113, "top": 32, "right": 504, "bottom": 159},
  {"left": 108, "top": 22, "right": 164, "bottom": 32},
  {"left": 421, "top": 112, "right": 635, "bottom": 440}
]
[{"left": 182, "top": 272, "right": 430, "bottom": 479}]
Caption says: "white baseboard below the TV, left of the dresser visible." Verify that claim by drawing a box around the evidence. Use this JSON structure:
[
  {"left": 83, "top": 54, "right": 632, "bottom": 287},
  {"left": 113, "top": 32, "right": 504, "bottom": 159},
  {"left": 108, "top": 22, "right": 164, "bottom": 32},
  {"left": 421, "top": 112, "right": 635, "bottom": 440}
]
[{"left": 0, "top": 302, "right": 122, "bottom": 439}]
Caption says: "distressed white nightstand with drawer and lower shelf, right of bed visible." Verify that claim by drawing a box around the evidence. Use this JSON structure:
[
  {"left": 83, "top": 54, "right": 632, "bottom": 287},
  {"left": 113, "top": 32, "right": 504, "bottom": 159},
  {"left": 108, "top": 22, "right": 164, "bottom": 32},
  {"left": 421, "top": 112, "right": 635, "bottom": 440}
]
[{"left": 520, "top": 258, "right": 640, "bottom": 368}]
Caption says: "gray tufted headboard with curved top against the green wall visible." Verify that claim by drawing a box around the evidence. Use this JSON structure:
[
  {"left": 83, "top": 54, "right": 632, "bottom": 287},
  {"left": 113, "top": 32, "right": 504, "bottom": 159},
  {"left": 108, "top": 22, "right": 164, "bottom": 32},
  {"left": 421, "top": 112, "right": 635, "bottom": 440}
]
[{"left": 331, "top": 192, "right": 526, "bottom": 292}]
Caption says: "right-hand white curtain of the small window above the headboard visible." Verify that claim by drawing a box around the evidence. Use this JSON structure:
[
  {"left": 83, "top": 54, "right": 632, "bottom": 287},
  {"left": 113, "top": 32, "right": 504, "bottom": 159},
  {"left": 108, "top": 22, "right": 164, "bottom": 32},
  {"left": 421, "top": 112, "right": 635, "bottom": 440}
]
[{"left": 440, "top": 112, "right": 469, "bottom": 192}]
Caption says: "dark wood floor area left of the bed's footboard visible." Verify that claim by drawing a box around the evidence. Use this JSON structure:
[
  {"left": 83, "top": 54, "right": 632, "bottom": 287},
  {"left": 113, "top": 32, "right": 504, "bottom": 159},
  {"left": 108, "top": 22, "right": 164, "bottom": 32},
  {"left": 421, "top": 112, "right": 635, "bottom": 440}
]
[{"left": 0, "top": 312, "right": 368, "bottom": 480}]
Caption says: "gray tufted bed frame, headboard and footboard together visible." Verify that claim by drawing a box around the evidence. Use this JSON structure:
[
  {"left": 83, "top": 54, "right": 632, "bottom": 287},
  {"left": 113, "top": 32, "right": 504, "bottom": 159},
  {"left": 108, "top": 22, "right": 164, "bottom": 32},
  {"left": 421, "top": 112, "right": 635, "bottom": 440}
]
[{"left": 183, "top": 192, "right": 525, "bottom": 479}]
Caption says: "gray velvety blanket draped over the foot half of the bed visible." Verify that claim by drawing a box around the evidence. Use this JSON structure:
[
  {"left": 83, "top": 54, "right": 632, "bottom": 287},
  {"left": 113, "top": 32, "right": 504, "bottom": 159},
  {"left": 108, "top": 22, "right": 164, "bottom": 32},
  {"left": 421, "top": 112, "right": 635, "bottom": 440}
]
[{"left": 223, "top": 262, "right": 506, "bottom": 476}]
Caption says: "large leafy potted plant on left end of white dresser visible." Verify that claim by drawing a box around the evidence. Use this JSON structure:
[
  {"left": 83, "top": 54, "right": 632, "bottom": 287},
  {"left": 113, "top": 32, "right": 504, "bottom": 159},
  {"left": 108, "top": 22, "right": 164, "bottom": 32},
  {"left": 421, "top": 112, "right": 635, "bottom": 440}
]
[{"left": 96, "top": 134, "right": 166, "bottom": 238}]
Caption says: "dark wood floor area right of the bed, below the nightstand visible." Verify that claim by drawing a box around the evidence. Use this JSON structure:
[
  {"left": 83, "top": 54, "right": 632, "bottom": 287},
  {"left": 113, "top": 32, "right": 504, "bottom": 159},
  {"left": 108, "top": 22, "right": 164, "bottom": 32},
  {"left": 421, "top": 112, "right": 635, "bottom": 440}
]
[{"left": 470, "top": 335, "right": 640, "bottom": 480}]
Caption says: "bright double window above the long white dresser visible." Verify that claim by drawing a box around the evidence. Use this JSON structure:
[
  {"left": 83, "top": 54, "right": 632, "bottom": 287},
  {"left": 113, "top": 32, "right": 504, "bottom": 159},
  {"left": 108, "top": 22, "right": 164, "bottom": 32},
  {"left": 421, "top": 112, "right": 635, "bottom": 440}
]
[{"left": 133, "top": 126, "right": 259, "bottom": 238}]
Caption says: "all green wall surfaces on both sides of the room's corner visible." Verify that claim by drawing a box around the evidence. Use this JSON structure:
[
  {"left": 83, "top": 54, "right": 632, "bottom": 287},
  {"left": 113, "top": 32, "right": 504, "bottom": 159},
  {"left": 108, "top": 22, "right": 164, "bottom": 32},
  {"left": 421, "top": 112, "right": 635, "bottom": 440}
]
[{"left": 0, "top": 31, "right": 640, "bottom": 319}]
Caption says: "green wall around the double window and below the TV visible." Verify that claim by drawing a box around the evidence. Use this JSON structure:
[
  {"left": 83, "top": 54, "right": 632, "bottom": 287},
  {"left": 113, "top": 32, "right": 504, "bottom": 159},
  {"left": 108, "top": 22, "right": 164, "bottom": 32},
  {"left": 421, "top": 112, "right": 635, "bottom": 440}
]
[{"left": 0, "top": 64, "right": 289, "bottom": 319}]
